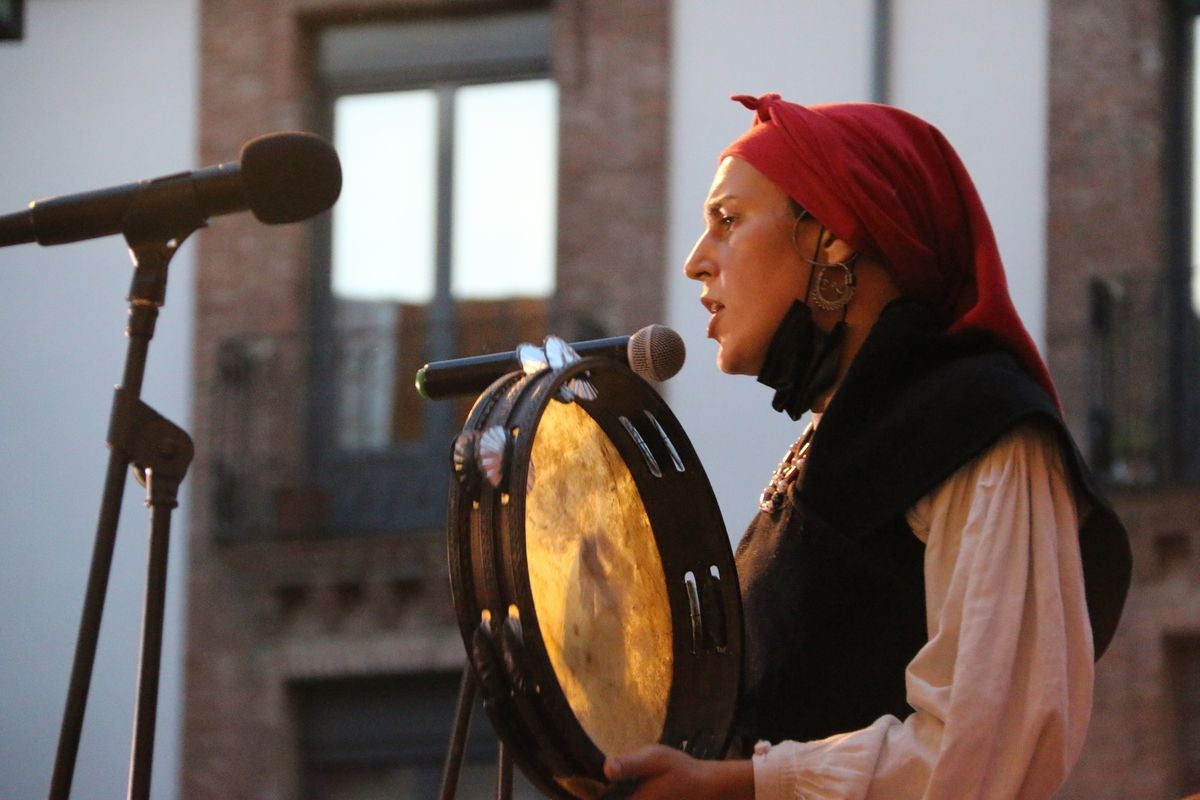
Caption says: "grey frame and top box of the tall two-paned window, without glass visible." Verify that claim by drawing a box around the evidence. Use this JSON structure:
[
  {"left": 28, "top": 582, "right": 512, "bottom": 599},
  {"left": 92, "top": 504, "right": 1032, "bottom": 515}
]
[{"left": 305, "top": 9, "right": 554, "bottom": 535}]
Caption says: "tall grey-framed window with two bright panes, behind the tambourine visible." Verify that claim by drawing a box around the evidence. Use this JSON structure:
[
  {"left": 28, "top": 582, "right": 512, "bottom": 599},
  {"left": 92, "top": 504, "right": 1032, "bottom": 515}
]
[{"left": 311, "top": 11, "right": 558, "bottom": 533}]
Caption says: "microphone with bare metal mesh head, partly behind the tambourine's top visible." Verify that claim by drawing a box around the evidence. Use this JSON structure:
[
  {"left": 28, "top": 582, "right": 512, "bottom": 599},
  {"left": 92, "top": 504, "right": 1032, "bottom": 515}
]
[{"left": 416, "top": 325, "right": 686, "bottom": 399}]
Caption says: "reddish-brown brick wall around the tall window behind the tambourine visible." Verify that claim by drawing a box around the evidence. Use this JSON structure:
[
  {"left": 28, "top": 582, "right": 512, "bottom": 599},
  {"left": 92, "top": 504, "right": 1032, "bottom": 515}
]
[{"left": 180, "top": 0, "right": 668, "bottom": 800}]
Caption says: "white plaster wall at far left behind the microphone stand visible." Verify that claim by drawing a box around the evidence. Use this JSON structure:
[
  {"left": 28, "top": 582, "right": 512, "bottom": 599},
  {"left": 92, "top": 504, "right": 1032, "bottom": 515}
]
[{"left": 0, "top": 0, "right": 199, "bottom": 800}]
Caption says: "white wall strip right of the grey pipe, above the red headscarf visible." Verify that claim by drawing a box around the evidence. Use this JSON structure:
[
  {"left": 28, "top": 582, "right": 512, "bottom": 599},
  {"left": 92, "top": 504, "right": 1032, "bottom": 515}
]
[{"left": 892, "top": 0, "right": 1050, "bottom": 347}]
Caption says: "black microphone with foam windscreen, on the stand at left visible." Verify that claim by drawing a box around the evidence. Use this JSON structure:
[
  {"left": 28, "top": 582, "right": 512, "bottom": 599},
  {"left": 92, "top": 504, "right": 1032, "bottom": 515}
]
[{"left": 0, "top": 132, "right": 342, "bottom": 247}]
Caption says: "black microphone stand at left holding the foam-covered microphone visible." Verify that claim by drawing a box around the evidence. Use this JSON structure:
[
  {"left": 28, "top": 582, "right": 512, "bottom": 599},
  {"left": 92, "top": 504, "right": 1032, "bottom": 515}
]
[{"left": 49, "top": 208, "right": 195, "bottom": 800}]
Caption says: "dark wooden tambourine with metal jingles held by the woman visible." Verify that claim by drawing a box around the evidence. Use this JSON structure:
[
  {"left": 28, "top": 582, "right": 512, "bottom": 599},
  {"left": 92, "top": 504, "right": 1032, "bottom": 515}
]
[{"left": 448, "top": 339, "right": 742, "bottom": 798}]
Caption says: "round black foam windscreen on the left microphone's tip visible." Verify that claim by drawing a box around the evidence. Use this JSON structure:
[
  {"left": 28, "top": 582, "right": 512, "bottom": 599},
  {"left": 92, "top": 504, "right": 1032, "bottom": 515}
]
[{"left": 241, "top": 132, "right": 342, "bottom": 225}]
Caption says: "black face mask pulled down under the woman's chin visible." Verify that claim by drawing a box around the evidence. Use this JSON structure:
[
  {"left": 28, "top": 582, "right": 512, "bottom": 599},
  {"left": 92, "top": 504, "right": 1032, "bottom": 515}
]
[{"left": 758, "top": 300, "right": 846, "bottom": 420}]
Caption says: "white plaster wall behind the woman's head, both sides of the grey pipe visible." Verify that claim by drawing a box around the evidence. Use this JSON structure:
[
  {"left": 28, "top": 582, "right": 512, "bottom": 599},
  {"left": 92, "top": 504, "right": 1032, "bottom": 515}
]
[{"left": 666, "top": 0, "right": 1046, "bottom": 541}]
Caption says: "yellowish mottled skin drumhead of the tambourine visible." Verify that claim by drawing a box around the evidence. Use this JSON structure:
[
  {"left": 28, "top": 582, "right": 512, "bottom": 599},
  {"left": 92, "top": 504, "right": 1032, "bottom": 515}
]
[{"left": 524, "top": 403, "right": 673, "bottom": 753}]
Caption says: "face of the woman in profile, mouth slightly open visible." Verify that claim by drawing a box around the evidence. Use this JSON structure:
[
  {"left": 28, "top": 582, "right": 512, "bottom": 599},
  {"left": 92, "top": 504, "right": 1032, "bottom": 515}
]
[{"left": 683, "top": 157, "right": 810, "bottom": 375}]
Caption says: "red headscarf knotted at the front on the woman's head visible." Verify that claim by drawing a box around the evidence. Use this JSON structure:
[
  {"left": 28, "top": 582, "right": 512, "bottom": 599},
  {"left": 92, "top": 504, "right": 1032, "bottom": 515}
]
[{"left": 721, "top": 94, "right": 1057, "bottom": 402}]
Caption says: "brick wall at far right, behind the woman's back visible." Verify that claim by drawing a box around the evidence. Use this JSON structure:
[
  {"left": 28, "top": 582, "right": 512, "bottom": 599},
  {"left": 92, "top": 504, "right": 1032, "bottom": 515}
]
[{"left": 1046, "top": 0, "right": 1200, "bottom": 800}]
